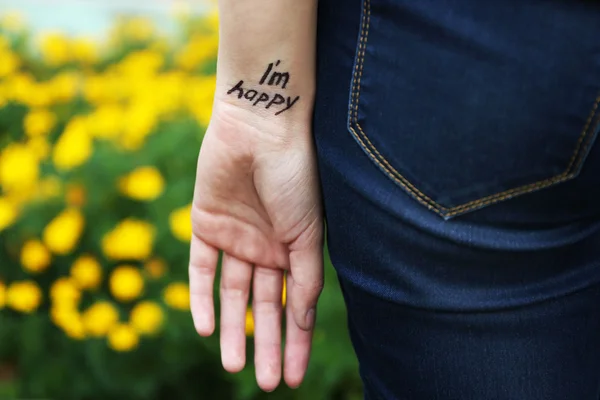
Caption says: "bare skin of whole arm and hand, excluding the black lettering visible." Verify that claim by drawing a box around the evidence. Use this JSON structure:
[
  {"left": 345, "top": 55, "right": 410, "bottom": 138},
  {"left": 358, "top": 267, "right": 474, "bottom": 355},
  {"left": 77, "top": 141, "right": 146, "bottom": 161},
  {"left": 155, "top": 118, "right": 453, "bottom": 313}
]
[{"left": 189, "top": 0, "right": 323, "bottom": 391}]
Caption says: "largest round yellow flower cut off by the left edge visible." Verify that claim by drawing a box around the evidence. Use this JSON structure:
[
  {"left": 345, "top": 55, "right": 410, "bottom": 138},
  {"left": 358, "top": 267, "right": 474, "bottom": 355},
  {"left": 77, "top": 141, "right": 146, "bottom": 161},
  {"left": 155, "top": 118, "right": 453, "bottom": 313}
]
[{"left": 0, "top": 143, "right": 39, "bottom": 191}]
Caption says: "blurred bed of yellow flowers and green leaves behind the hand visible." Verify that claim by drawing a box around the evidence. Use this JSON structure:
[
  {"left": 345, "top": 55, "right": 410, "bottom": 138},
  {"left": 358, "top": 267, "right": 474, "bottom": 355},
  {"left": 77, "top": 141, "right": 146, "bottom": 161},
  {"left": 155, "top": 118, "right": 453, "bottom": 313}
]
[{"left": 0, "top": 7, "right": 361, "bottom": 399}]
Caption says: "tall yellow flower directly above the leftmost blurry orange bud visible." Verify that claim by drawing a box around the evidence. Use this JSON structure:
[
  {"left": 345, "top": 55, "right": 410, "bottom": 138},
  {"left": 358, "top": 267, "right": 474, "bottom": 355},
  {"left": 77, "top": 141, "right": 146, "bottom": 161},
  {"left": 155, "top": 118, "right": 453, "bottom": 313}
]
[{"left": 52, "top": 118, "right": 92, "bottom": 170}]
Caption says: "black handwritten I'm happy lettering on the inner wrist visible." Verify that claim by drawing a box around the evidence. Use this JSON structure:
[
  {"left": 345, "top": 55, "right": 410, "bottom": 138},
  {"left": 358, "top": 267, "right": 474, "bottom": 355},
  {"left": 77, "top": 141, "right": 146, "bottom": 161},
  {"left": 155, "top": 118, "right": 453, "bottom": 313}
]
[{"left": 227, "top": 60, "right": 300, "bottom": 115}]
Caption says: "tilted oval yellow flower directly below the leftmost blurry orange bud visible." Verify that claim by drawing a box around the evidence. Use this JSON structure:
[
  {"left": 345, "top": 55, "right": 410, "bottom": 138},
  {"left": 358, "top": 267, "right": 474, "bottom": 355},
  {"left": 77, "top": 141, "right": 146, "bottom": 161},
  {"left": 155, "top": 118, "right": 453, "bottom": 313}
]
[{"left": 42, "top": 208, "right": 85, "bottom": 255}]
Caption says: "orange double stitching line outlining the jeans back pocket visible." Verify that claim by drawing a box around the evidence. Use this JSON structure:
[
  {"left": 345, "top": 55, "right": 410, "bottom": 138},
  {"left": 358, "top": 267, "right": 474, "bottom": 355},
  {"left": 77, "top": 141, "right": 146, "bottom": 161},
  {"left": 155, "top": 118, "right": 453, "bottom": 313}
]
[{"left": 348, "top": 0, "right": 600, "bottom": 217}]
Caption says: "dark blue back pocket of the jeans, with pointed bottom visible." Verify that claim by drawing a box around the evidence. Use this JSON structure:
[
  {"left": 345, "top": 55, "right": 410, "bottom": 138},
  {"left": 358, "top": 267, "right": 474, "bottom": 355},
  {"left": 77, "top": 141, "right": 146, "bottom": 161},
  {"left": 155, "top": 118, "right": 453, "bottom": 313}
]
[{"left": 348, "top": 0, "right": 600, "bottom": 219}]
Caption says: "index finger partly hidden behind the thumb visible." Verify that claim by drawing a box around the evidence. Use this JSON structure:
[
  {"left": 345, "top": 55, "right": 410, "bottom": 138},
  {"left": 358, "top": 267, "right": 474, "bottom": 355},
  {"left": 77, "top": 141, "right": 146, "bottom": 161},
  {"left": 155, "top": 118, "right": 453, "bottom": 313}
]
[{"left": 283, "top": 275, "right": 313, "bottom": 388}]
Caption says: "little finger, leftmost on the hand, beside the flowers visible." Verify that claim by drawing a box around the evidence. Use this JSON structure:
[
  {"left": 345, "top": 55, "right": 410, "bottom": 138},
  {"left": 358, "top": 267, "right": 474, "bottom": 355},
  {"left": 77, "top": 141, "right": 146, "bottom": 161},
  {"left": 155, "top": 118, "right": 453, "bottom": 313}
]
[{"left": 189, "top": 235, "right": 219, "bottom": 336}]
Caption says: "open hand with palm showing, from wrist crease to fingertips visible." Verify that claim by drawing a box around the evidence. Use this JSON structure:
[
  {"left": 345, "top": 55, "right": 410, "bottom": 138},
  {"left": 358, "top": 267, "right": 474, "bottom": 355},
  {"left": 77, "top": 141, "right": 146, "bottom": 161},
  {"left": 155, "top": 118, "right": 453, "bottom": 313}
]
[{"left": 189, "top": 103, "right": 323, "bottom": 391}]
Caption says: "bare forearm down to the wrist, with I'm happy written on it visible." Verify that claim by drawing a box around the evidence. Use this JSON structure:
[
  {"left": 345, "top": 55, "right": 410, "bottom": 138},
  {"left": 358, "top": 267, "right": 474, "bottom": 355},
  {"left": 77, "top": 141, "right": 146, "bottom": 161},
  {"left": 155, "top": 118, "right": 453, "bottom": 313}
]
[{"left": 216, "top": 0, "right": 317, "bottom": 121}]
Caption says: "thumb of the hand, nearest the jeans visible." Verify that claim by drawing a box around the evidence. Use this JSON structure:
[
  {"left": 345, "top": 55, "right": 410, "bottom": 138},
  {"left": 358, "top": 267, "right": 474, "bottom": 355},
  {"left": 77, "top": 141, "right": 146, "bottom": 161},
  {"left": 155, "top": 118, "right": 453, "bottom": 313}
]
[{"left": 288, "top": 245, "right": 323, "bottom": 331}]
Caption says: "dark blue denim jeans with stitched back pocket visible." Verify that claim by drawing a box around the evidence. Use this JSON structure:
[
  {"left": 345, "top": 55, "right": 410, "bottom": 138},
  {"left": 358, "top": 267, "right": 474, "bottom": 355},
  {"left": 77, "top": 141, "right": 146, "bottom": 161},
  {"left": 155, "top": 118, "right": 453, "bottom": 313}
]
[{"left": 314, "top": 0, "right": 600, "bottom": 400}]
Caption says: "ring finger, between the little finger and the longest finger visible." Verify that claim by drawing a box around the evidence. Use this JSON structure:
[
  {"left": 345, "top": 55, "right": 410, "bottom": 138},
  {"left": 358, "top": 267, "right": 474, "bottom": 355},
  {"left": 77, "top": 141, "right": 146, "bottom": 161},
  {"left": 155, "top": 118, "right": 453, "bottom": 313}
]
[{"left": 220, "top": 254, "right": 252, "bottom": 372}]
